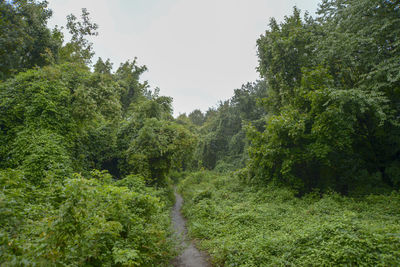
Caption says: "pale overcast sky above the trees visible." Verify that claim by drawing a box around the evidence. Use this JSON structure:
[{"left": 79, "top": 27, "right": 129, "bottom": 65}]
[{"left": 49, "top": 0, "right": 319, "bottom": 115}]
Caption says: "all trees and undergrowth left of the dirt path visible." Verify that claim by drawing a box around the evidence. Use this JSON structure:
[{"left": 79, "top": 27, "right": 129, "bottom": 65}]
[{"left": 0, "top": 0, "right": 196, "bottom": 266}]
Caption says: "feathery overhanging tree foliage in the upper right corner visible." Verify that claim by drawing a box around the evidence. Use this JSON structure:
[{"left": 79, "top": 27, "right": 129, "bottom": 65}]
[{"left": 316, "top": 0, "right": 400, "bottom": 94}]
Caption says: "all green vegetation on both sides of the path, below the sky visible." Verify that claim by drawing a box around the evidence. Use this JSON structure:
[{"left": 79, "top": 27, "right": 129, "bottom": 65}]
[{"left": 0, "top": 0, "right": 400, "bottom": 266}]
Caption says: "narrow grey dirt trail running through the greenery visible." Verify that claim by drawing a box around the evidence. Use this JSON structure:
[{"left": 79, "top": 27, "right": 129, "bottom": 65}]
[{"left": 172, "top": 190, "right": 211, "bottom": 267}]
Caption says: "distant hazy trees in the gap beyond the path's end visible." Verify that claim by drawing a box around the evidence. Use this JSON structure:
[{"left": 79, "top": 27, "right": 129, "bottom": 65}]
[{"left": 176, "top": 81, "right": 267, "bottom": 171}]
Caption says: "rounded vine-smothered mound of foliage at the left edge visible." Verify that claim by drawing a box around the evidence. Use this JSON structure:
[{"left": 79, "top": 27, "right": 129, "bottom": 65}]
[{"left": 0, "top": 64, "right": 126, "bottom": 178}]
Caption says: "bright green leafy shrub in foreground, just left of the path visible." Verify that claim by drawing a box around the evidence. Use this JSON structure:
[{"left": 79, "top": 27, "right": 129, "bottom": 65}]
[{"left": 40, "top": 177, "right": 169, "bottom": 266}]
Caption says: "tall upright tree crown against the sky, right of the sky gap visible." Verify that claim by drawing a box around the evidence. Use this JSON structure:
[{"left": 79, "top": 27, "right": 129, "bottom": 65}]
[{"left": 257, "top": 8, "right": 314, "bottom": 112}]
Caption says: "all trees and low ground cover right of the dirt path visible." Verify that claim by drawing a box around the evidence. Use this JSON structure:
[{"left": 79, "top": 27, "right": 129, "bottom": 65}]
[{"left": 177, "top": 0, "right": 400, "bottom": 266}]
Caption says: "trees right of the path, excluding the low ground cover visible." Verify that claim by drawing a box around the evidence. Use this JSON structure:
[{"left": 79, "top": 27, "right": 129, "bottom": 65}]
[{"left": 184, "top": 0, "right": 400, "bottom": 195}]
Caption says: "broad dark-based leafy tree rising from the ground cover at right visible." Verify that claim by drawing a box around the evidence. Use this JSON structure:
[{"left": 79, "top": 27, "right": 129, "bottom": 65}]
[{"left": 248, "top": 69, "right": 394, "bottom": 193}]
